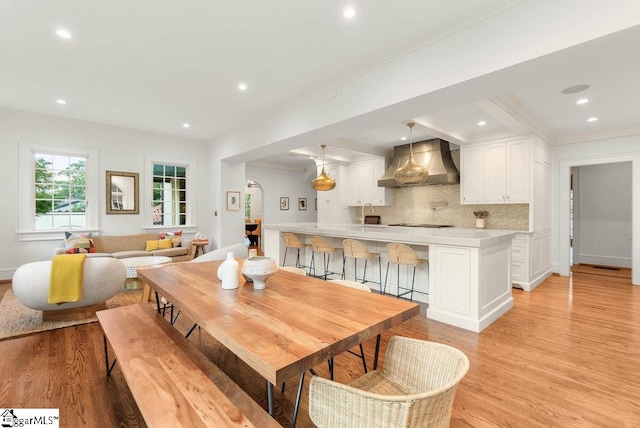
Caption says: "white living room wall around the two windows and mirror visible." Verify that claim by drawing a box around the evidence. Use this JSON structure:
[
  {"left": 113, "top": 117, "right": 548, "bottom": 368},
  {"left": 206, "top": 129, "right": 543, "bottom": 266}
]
[{"left": 0, "top": 109, "right": 212, "bottom": 279}]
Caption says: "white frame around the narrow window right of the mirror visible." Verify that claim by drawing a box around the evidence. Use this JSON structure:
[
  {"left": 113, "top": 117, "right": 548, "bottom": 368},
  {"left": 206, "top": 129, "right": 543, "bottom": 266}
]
[{"left": 141, "top": 156, "right": 198, "bottom": 230}]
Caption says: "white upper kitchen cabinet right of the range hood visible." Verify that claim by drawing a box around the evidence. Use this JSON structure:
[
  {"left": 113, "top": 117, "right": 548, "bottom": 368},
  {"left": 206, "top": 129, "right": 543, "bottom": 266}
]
[{"left": 460, "top": 137, "right": 531, "bottom": 204}]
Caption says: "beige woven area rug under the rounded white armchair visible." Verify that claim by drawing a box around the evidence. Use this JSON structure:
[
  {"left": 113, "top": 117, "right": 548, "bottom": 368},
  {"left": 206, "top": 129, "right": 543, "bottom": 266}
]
[{"left": 0, "top": 289, "right": 142, "bottom": 340}]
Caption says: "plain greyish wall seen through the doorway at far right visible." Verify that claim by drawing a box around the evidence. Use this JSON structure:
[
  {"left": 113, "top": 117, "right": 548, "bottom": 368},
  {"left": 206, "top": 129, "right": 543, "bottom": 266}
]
[{"left": 573, "top": 162, "right": 632, "bottom": 267}]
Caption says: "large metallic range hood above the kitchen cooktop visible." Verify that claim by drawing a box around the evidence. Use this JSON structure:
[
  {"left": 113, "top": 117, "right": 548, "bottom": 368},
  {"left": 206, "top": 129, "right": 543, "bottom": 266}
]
[{"left": 378, "top": 138, "right": 460, "bottom": 187}]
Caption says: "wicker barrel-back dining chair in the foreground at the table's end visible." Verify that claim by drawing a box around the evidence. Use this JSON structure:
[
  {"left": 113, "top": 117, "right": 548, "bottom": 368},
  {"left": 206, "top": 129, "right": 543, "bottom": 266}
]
[{"left": 309, "top": 336, "right": 469, "bottom": 428}]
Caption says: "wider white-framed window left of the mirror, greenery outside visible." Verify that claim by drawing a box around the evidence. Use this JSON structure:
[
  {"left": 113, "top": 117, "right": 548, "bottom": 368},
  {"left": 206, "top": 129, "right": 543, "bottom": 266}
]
[{"left": 19, "top": 143, "right": 98, "bottom": 236}]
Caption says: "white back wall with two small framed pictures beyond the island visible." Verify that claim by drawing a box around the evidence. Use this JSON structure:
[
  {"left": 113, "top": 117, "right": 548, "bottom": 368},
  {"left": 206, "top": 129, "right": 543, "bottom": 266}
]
[{"left": 245, "top": 165, "right": 317, "bottom": 224}]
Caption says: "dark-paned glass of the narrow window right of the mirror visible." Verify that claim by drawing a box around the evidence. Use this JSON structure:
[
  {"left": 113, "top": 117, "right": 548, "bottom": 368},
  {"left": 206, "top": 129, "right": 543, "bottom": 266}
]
[{"left": 152, "top": 163, "right": 187, "bottom": 226}]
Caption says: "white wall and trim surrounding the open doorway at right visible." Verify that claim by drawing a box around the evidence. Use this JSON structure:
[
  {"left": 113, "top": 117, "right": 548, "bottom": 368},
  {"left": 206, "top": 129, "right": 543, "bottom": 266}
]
[{"left": 551, "top": 135, "right": 640, "bottom": 285}]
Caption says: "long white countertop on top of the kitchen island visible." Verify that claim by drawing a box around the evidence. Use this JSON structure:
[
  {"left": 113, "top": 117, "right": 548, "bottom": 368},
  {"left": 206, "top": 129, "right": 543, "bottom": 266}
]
[{"left": 262, "top": 222, "right": 516, "bottom": 248}]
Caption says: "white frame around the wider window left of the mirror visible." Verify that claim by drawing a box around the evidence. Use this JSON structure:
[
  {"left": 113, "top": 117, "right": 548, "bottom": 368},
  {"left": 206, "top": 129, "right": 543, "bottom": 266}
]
[{"left": 18, "top": 141, "right": 100, "bottom": 241}]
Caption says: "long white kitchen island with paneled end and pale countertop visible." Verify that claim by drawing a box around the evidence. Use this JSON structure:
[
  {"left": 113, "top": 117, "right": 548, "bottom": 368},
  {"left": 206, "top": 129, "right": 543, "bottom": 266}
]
[{"left": 263, "top": 223, "right": 515, "bottom": 332}]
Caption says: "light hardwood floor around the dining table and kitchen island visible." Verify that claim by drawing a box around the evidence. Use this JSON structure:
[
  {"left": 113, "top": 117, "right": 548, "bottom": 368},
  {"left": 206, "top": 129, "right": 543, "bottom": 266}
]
[{"left": 0, "top": 273, "right": 640, "bottom": 427}]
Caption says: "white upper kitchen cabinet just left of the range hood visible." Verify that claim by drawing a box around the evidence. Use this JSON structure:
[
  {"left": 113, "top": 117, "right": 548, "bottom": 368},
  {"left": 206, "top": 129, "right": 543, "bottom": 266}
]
[{"left": 345, "top": 158, "right": 393, "bottom": 206}]
